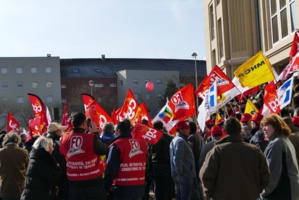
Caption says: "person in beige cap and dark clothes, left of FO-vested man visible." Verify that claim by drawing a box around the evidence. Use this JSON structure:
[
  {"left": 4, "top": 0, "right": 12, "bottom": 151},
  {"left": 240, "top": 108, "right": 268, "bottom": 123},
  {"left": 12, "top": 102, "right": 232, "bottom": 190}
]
[{"left": 45, "top": 122, "right": 69, "bottom": 200}]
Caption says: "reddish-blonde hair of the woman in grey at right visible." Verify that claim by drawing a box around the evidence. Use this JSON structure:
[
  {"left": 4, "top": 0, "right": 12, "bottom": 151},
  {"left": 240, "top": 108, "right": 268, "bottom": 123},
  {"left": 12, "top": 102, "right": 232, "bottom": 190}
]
[{"left": 261, "top": 114, "right": 291, "bottom": 137}]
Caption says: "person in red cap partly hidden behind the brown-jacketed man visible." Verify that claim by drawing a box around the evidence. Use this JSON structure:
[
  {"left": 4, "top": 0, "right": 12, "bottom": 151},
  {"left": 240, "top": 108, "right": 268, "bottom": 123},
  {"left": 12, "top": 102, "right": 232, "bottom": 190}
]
[{"left": 199, "top": 126, "right": 223, "bottom": 170}]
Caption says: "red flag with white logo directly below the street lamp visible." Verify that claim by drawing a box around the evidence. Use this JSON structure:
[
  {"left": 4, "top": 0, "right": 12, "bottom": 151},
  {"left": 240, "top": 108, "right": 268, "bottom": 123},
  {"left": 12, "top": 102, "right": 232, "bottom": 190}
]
[{"left": 169, "top": 84, "right": 196, "bottom": 120}]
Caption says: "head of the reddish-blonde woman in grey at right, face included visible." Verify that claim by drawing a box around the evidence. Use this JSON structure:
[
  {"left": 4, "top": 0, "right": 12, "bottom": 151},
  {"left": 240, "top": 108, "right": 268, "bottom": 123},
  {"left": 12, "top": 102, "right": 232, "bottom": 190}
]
[{"left": 261, "top": 114, "right": 291, "bottom": 138}]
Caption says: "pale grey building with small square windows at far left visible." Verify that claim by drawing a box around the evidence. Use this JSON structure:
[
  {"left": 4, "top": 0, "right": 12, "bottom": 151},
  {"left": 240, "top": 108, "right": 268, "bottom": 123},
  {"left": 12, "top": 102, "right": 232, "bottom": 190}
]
[{"left": 0, "top": 55, "right": 61, "bottom": 105}]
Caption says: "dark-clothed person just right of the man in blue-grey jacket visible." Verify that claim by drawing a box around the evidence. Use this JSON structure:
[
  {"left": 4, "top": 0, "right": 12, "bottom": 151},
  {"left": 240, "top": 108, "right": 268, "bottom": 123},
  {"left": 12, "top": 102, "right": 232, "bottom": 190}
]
[{"left": 188, "top": 122, "right": 204, "bottom": 200}]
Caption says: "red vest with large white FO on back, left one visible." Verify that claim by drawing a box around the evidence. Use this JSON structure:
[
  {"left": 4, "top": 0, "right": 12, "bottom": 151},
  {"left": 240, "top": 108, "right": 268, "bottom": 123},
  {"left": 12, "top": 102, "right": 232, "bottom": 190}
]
[{"left": 60, "top": 132, "right": 104, "bottom": 181}]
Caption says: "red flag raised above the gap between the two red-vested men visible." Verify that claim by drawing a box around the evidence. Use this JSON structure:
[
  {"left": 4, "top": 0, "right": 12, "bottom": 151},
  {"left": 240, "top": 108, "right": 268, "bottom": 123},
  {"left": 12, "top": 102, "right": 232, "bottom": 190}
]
[{"left": 85, "top": 100, "right": 113, "bottom": 131}]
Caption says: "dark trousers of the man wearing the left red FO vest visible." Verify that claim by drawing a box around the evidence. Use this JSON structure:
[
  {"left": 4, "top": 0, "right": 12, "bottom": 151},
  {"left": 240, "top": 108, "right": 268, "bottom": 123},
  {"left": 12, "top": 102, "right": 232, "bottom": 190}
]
[{"left": 69, "top": 185, "right": 106, "bottom": 200}]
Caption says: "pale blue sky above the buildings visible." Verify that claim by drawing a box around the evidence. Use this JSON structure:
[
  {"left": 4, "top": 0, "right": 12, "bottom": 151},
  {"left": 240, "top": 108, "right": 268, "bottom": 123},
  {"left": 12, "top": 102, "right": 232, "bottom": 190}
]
[{"left": 0, "top": 0, "right": 206, "bottom": 60}]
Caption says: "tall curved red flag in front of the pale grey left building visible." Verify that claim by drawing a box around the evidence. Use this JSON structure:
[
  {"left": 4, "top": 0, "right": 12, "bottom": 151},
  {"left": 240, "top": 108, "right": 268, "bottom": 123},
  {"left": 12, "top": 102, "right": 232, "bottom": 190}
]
[{"left": 28, "top": 93, "right": 48, "bottom": 132}]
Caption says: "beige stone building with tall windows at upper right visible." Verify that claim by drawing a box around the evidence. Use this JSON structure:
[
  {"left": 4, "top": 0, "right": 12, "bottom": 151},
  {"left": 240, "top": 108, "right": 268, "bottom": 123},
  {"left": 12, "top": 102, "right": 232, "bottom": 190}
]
[{"left": 204, "top": 0, "right": 299, "bottom": 78}]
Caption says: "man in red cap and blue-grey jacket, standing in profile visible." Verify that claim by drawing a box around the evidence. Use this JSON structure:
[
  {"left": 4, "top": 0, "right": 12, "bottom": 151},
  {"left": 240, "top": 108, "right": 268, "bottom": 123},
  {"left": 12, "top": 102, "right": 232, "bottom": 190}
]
[{"left": 170, "top": 121, "right": 199, "bottom": 200}]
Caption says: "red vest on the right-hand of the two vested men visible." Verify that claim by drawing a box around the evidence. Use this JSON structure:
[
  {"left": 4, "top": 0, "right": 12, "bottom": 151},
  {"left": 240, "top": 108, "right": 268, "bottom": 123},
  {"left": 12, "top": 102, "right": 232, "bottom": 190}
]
[{"left": 113, "top": 138, "right": 147, "bottom": 186}]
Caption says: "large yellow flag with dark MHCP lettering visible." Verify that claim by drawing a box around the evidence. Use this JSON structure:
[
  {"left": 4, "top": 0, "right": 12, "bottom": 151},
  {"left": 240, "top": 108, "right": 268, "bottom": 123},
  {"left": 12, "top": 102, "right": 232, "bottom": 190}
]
[{"left": 234, "top": 51, "right": 274, "bottom": 88}]
